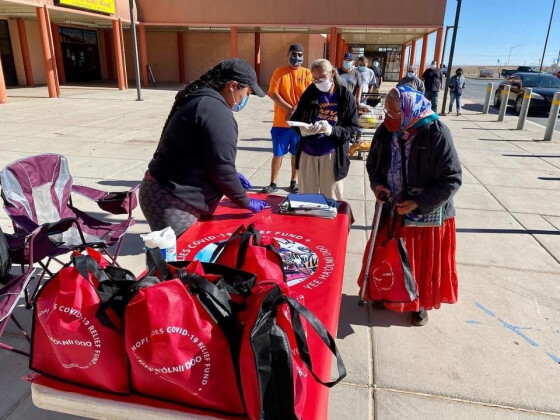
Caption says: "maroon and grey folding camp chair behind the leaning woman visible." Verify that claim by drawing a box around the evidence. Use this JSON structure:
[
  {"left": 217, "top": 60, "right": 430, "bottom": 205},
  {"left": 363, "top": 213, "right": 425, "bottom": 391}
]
[{"left": 0, "top": 153, "right": 138, "bottom": 302}]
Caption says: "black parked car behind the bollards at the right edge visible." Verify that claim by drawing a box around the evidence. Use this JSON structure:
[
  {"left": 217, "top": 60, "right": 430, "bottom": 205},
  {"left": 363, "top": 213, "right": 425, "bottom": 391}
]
[{"left": 494, "top": 73, "right": 560, "bottom": 114}]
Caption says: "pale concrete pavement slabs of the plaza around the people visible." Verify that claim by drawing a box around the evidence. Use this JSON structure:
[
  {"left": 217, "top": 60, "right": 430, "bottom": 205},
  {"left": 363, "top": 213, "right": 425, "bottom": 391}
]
[{"left": 0, "top": 86, "right": 560, "bottom": 420}]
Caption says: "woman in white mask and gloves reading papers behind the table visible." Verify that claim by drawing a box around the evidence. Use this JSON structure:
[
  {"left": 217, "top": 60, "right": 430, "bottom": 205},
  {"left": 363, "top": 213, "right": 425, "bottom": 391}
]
[{"left": 292, "top": 59, "right": 359, "bottom": 200}]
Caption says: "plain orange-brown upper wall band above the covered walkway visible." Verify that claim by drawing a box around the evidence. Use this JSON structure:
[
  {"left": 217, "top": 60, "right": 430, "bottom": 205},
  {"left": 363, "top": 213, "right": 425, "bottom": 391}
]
[{"left": 137, "top": 0, "right": 446, "bottom": 27}]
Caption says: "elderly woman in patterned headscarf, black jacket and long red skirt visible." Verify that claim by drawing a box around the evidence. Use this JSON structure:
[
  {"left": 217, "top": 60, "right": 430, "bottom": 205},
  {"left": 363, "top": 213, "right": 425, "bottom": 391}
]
[{"left": 366, "top": 86, "right": 461, "bottom": 325}]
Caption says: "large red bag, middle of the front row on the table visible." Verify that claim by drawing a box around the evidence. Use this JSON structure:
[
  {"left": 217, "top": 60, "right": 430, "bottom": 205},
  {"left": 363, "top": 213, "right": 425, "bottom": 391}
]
[{"left": 125, "top": 249, "right": 254, "bottom": 414}]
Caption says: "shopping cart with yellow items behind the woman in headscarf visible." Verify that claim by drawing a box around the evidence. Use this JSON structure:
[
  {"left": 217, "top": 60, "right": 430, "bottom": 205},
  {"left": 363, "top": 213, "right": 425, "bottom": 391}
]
[{"left": 349, "top": 93, "right": 387, "bottom": 159}]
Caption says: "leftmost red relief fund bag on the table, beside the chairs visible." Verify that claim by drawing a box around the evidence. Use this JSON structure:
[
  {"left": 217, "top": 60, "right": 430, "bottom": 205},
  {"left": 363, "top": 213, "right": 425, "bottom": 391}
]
[{"left": 30, "top": 255, "right": 136, "bottom": 393}]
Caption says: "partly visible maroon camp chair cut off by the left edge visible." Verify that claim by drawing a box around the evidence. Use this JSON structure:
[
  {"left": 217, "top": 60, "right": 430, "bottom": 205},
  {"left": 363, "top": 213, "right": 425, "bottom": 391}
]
[{"left": 0, "top": 266, "right": 34, "bottom": 357}]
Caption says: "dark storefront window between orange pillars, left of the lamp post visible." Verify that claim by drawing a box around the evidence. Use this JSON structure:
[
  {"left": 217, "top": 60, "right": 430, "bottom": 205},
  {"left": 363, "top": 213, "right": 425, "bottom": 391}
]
[{"left": 60, "top": 27, "right": 101, "bottom": 82}]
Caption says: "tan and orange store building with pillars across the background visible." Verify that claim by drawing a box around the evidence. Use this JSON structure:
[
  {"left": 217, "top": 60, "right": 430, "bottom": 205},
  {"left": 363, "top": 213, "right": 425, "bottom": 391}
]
[{"left": 0, "top": 0, "right": 446, "bottom": 103}]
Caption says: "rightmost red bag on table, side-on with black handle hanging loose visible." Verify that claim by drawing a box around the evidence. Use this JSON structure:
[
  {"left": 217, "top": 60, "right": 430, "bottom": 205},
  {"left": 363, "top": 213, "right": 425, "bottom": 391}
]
[{"left": 239, "top": 282, "right": 346, "bottom": 419}]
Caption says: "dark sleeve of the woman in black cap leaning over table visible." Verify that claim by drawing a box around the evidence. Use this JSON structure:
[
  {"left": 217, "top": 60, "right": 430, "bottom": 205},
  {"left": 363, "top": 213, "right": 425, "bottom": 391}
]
[{"left": 196, "top": 99, "right": 249, "bottom": 207}]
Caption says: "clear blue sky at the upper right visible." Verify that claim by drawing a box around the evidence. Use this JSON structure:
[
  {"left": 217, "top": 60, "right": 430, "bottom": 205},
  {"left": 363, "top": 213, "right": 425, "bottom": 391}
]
[{"left": 440, "top": 0, "right": 560, "bottom": 67}]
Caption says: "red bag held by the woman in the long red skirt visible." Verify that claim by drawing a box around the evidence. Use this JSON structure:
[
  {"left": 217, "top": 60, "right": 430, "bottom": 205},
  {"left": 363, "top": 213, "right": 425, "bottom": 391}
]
[{"left": 358, "top": 224, "right": 418, "bottom": 303}]
